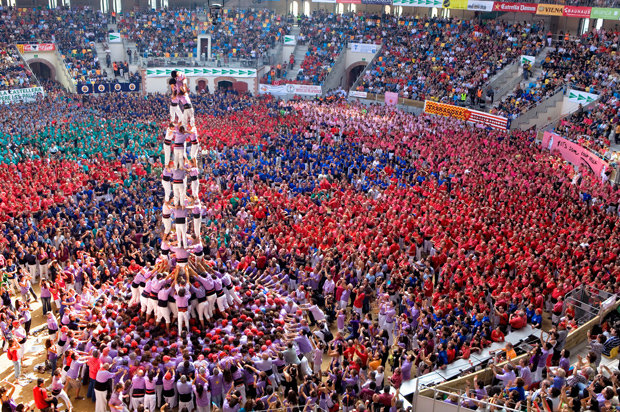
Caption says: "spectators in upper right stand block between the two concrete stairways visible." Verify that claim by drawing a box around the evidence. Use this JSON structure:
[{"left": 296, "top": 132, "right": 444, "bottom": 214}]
[{"left": 493, "top": 30, "right": 620, "bottom": 118}]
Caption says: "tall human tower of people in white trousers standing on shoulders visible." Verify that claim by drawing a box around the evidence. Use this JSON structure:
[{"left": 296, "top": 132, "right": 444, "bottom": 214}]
[{"left": 132, "top": 71, "right": 241, "bottom": 335}]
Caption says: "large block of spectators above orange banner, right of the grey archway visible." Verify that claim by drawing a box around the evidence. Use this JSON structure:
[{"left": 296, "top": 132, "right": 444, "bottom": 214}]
[{"left": 358, "top": 16, "right": 544, "bottom": 103}]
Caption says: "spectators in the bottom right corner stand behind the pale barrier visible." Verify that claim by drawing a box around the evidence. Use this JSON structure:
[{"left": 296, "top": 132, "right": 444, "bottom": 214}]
[{"left": 444, "top": 316, "right": 620, "bottom": 412}]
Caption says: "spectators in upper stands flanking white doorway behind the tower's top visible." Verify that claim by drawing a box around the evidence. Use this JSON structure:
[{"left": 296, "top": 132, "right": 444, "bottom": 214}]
[{"left": 118, "top": 9, "right": 289, "bottom": 61}]
